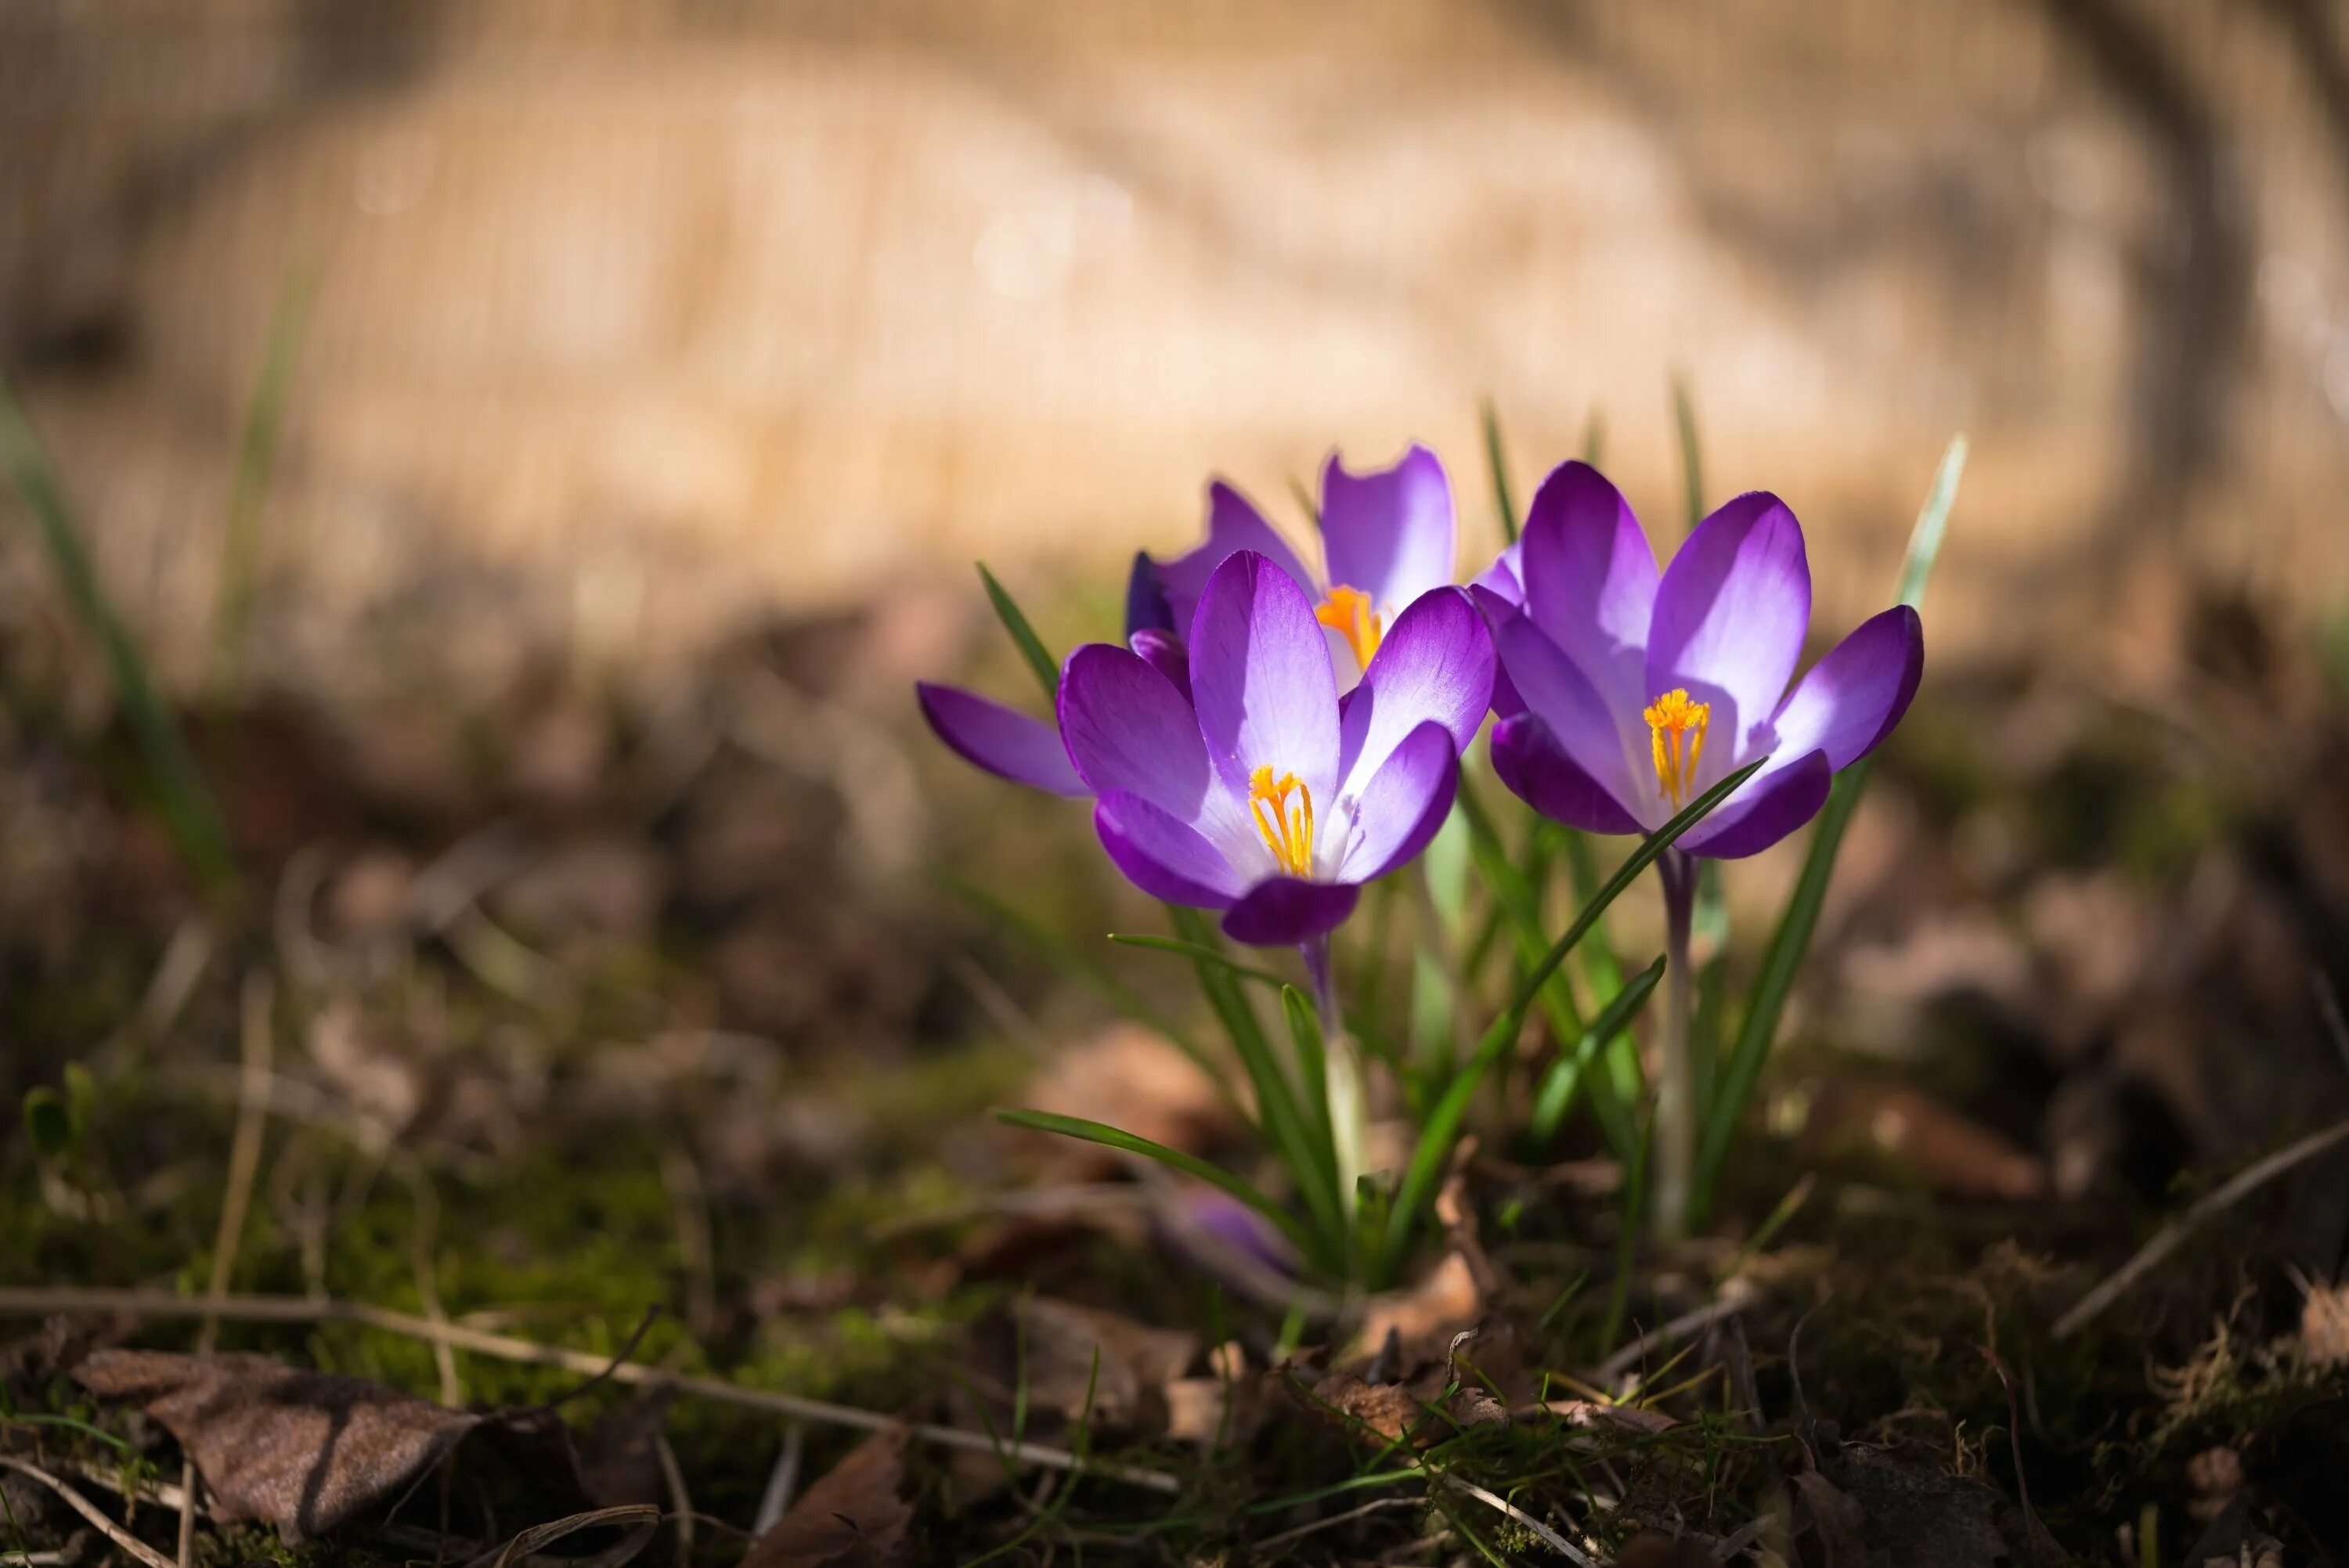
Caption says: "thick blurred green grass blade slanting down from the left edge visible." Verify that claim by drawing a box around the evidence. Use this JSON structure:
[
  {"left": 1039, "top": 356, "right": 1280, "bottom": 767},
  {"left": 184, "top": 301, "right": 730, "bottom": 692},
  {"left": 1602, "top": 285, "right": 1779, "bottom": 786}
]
[{"left": 0, "top": 363, "right": 237, "bottom": 889}]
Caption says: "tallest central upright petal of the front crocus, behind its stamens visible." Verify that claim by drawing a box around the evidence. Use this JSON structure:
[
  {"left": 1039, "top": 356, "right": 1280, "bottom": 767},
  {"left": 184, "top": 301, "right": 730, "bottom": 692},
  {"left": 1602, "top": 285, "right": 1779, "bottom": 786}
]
[{"left": 1193, "top": 550, "right": 1337, "bottom": 802}]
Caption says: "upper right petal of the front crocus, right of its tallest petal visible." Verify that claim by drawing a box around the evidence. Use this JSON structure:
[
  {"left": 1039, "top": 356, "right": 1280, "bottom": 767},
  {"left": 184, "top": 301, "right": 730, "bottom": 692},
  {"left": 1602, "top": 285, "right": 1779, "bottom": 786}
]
[{"left": 1339, "top": 587, "right": 1494, "bottom": 798}]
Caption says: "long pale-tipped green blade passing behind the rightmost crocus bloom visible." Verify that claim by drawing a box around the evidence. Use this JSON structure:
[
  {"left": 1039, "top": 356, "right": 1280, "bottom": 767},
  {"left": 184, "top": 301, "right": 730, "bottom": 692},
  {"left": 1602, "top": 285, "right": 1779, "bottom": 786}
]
[{"left": 1689, "top": 437, "right": 1966, "bottom": 1223}]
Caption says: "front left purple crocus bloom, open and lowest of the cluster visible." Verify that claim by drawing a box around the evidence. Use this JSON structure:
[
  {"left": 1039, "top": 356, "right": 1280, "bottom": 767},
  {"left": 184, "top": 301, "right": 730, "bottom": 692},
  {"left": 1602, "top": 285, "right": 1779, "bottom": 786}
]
[{"left": 1059, "top": 550, "right": 1494, "bottom": 946}]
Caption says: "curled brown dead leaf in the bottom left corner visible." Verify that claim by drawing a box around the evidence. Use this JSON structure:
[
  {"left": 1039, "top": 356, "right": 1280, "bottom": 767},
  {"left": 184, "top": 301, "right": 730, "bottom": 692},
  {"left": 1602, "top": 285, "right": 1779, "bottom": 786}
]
[{"left": 73, "top": 1350, "right": 482, "bottom": 1542}]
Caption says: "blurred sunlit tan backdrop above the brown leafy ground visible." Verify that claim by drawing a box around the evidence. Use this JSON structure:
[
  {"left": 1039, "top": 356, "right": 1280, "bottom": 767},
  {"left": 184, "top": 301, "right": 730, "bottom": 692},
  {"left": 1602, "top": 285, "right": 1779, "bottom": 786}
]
[{"left": 13, "top": 0, "right": 2349, "bottom": 702}]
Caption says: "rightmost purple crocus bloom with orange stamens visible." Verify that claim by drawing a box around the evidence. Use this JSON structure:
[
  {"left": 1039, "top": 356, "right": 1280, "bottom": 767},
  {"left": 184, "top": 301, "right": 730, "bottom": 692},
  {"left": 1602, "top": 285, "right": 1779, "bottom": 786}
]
[{"left": 1478, "top": 463, "right": 1924, "bottom": 859}]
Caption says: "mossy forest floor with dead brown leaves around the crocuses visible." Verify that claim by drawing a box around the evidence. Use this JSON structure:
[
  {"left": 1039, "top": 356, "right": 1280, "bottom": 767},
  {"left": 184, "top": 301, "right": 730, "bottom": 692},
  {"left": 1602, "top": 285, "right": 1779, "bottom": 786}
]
[{"left": 0, "top": 582, "right": 2349, "bottom": 1568}]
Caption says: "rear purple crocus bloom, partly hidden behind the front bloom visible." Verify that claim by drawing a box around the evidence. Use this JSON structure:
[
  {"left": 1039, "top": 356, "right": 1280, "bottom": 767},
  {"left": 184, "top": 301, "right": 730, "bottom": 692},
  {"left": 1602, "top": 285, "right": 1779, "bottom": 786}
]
[{"left": 1146, "top": 446, "right": 1456, "bottom": 669}]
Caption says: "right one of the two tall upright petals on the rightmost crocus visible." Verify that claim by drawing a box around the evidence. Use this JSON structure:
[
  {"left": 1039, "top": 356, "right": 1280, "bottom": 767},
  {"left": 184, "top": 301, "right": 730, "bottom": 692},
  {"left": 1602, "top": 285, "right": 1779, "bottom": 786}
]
[{"left": 1647, "top": 491, "right": 1811, "bottom": 755}]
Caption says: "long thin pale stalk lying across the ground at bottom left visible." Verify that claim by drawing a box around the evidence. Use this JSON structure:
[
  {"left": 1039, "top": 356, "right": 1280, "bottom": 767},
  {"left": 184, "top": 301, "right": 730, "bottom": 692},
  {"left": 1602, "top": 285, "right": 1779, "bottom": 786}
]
[{"left": 0, "top": 1286, "right": 1182, "bottom": 1493}]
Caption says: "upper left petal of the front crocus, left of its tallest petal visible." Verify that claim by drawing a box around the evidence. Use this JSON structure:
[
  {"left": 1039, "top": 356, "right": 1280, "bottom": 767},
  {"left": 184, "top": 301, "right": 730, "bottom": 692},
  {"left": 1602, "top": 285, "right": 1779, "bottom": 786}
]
[{"left": 1059, "top": 643, "right": 1217, "bottom": 821}]
